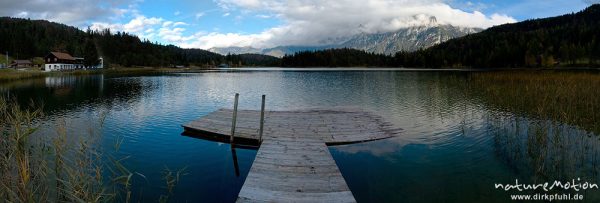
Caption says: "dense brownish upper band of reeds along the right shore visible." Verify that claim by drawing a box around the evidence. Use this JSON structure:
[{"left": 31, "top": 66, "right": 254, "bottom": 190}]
[{"left": 470, "top": 71, "right": 600, "bottom": 133}]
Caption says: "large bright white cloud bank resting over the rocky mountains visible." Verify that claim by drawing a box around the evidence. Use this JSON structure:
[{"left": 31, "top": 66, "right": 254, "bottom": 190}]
[{"left": 203, "top": 0, "right": 516, "bottom": 47}]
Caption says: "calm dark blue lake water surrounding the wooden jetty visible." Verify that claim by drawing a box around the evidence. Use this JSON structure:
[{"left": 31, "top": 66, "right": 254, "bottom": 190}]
[{"left": 0, "top": 70, "right": 600, "bottom": 202}]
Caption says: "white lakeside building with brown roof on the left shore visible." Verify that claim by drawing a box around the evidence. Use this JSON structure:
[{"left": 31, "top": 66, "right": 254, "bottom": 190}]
[{"left": 44, "top": 52, "right": 104, "bottom": 71}]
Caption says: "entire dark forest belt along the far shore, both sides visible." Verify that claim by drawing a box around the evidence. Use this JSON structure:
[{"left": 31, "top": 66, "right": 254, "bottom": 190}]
[{"left": 0, "top": 4, "right": 600, "bottom": 68}]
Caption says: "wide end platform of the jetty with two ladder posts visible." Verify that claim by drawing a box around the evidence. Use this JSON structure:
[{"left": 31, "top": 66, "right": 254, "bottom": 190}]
[{"left": 183, "top": 109, "right": 400, "bottom": 144}]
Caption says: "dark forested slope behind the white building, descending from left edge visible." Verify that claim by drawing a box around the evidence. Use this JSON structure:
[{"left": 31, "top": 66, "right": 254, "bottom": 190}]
[{"left": 0, "top": 17, "right": 278, "bottom": 67}]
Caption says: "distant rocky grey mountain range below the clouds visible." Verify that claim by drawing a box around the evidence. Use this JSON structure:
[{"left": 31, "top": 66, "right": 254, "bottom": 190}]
[{"left": 209, "top": 17, "right": 482, "bottom": 57}]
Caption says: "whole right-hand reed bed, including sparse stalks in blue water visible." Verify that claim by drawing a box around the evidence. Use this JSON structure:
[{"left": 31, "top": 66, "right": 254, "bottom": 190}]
[{"left": 467, "top": 71, "right": 600, "bottom": 190}]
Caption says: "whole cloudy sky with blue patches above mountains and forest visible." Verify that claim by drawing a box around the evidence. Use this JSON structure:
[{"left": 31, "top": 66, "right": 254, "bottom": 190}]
[{"left": 0, "top": 0, "right": 600, "bottom": 49}]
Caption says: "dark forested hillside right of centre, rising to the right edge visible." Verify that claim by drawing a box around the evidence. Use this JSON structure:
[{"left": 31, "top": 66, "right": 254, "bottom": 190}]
[{"left": 282, "top": 4, "right": 600, "bottom": 68}]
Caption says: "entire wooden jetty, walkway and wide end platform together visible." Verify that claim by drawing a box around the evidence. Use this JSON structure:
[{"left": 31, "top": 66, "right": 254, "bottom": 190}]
[{"left": 183, "top": 109, "right": 401, "bottom": 202}]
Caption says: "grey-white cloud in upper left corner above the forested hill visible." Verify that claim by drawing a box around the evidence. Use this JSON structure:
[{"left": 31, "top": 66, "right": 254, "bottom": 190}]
[{"left": 0, "top": 0, "right": 133, "bottom": 26}]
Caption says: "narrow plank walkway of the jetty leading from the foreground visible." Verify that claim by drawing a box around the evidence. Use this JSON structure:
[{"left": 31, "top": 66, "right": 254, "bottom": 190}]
[{"left": 237, "top": 138, "right": 356, "bottom": 202}]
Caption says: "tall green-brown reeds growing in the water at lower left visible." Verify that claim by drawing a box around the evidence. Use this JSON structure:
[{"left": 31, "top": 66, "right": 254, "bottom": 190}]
[{"left": 0, "top": 98, "right": 185, "bottom": 202}]
